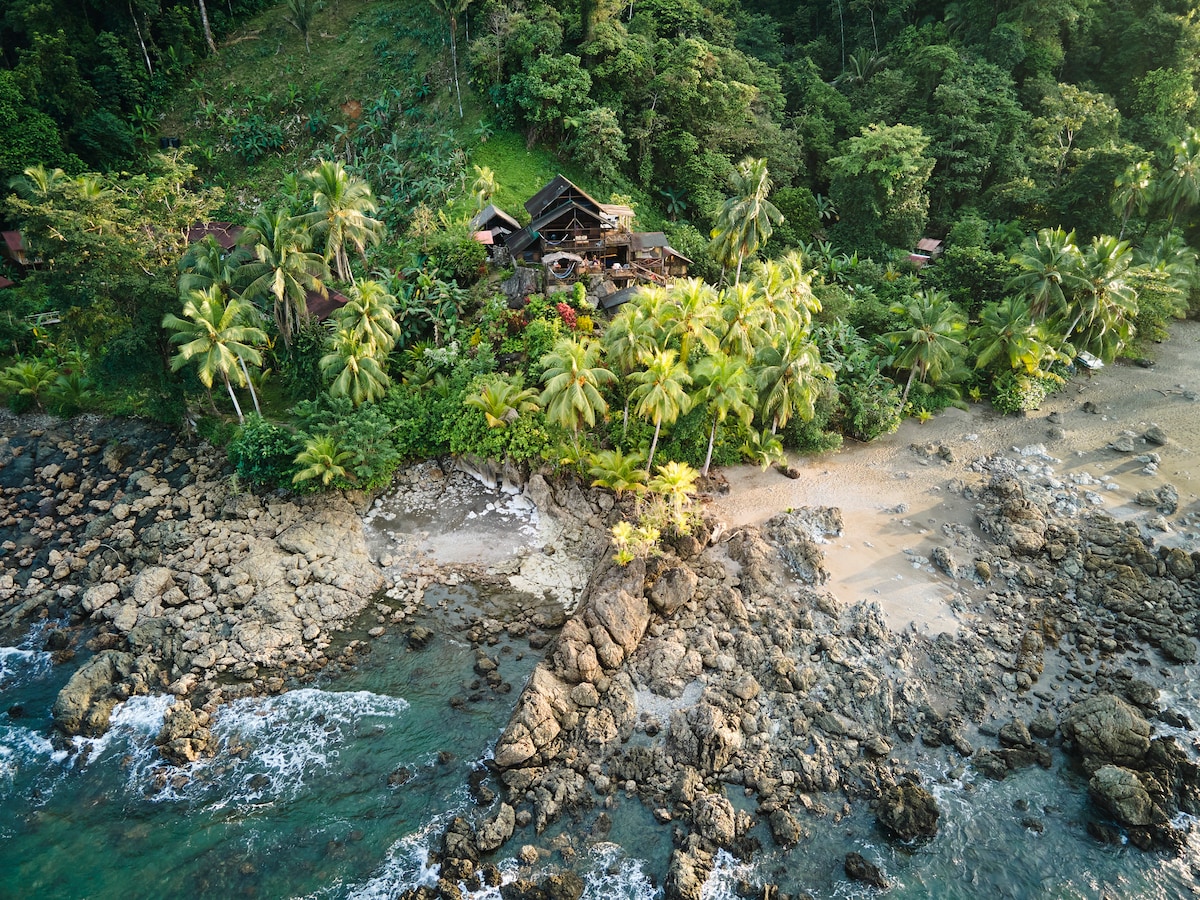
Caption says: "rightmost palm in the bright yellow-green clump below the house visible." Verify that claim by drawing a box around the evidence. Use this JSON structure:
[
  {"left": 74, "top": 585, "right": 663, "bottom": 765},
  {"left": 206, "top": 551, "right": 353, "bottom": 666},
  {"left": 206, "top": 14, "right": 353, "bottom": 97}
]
[{"left": 755, "top": 322, "right": 834, "bottom": 434}]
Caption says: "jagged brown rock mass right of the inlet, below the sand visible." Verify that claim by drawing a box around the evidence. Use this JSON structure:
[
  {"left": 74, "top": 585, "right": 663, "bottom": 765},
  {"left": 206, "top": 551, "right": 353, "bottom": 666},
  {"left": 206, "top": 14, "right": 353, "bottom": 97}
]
[{"left": 408, "top": 446, "right": 1200, "bottom": 900}]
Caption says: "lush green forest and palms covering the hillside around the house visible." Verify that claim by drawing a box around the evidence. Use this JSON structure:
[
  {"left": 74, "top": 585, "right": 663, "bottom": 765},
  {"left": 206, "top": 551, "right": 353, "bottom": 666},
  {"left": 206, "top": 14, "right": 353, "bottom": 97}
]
[{"left": 0, "top": 0, "right": 1200, "bottom": 540}]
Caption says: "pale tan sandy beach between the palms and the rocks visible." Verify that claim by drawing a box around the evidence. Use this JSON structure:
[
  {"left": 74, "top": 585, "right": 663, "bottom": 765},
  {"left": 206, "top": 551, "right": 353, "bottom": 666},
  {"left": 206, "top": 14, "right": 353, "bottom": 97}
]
[{"left": 710, "top": 322, "right": 1200, "bottom": 634}]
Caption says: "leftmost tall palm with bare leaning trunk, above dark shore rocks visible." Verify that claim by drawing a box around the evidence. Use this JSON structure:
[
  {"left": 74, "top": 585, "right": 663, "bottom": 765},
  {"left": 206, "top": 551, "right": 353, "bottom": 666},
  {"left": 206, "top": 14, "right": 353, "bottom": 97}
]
[{"left": 162, "top": 287, "right": 266, "bottom": 422}]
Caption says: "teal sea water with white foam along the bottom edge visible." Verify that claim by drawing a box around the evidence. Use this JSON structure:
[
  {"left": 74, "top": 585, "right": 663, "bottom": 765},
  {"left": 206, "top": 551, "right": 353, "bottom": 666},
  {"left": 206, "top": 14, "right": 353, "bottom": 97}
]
[{"left": 0, "top": 589, "right": 1200, "bottom": 900}]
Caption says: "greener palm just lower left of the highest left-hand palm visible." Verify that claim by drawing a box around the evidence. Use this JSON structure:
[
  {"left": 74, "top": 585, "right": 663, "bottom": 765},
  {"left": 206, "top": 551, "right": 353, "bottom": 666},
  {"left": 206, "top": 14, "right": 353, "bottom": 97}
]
[{"left": 239, "top": 208, "right": 329, "bottom": 344}]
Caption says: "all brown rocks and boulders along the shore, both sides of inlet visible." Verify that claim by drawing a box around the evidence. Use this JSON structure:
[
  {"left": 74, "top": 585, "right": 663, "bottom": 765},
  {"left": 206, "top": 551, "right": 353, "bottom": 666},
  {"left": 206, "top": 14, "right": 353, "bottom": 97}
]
[{"left": 0, "top": 418, "right": 1200, "bottom": 898}]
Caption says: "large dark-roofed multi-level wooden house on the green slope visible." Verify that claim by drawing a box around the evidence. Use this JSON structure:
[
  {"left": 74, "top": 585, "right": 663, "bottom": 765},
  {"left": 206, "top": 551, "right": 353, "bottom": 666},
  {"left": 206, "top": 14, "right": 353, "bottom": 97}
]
[{"left": 505, "top": 175, "right": 689, "bottom": 289}]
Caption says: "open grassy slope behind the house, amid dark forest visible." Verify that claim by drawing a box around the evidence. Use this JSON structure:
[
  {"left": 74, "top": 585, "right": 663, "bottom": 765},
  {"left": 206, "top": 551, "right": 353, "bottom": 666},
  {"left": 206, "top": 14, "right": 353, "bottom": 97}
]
[{"left": 161, "top": 0, "right": 665, "bottom": 229}]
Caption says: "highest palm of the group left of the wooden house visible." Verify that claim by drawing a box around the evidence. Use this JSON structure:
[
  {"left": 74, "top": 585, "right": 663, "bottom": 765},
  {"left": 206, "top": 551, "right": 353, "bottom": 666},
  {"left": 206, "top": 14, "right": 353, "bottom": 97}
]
[{"left": 304, "top": 161, "right": 384, "bottom": 282}]
